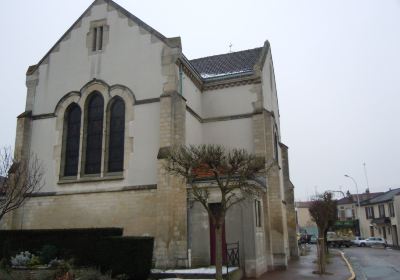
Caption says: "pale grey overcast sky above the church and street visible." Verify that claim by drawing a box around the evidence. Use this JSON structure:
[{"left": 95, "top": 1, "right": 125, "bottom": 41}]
[{"left": 0, "top": 0, "right": 400, "bottom": 200}]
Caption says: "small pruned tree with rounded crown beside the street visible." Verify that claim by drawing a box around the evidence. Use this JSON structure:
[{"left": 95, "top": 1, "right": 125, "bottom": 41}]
[{"left": 309, "top": 192, "right": 337, "bottom": 274}]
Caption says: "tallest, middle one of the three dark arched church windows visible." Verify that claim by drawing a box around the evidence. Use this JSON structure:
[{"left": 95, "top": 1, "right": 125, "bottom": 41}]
[{"left": 85, "top": 92, "right": 104, "bottom": 174}]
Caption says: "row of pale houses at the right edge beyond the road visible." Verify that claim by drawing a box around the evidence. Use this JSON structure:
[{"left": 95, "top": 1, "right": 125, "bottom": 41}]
[{"left": 360, "top": 188, "right": 400, "bottom": 246}]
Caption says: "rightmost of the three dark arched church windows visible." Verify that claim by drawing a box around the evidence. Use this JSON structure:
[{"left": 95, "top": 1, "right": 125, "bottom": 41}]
[{"left": 107, "top": 97, "right": 125, "bottom": 172}]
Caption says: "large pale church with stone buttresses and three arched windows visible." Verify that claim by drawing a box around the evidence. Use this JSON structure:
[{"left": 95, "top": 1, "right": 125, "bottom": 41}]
[{"left": 1, "top": 0, "right": 298, "bottom": 277}]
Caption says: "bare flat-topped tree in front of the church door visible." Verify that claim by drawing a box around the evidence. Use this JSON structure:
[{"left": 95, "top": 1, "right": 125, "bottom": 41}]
[{"left": 166, "top": 145, "right": 273, "bottom": 279}]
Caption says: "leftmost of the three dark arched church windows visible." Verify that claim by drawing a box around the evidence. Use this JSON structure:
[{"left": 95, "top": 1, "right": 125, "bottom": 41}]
[{"left": 63, "top": 103, "right": 81, "bottom": 176}]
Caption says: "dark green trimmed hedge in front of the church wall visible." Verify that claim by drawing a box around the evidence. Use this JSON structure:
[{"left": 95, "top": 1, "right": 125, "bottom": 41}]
[{"left": 0, "top": 228, "right": 154, "bottom": 279}]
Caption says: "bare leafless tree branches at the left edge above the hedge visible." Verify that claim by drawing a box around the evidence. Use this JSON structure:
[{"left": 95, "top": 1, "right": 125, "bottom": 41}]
[{"left": 0, "top": 148, "right": 44, "bottom": 220}]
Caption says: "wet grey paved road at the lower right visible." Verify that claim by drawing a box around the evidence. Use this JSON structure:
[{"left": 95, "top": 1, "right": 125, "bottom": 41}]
[{"left": 343, "top": 247, "right": 400, "bottom": 280}]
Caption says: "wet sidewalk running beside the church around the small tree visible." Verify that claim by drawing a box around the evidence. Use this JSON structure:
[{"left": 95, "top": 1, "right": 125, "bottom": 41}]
[{"left": 248, "top": 245, "right": 351, "bottom": 280}]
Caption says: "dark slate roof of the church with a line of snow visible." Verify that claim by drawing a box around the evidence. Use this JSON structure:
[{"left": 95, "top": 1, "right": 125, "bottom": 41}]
[{"left": 189, "top": 48, "right": 262, "bottom": 80}]
